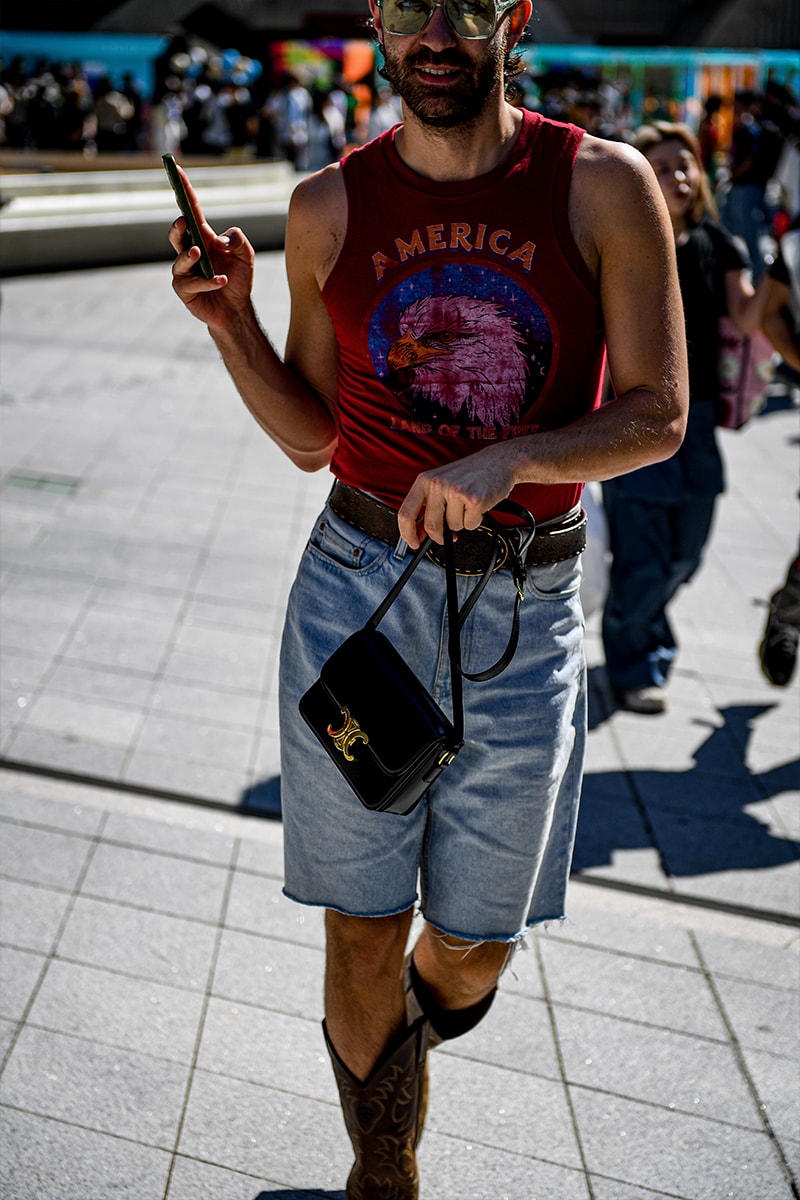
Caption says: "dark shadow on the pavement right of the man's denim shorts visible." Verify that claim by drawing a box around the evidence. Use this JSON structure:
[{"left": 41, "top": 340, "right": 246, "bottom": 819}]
[{"left": 573, "top": 688, "right": 800, "bottom": 877}]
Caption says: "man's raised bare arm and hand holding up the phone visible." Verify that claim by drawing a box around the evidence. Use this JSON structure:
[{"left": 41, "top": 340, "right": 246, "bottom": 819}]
[{"left": 170, "top": 162, "right": 337, "bottom": 470}]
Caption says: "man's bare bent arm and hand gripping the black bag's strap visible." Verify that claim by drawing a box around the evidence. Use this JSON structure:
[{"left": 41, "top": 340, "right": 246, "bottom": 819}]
[{"left": 399, "top": 138, "right": 688, "bottom": 546}]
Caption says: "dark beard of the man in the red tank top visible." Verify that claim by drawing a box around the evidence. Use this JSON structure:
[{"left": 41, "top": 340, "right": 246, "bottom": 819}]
[{"left": 380, "top": 36, "right": 505, "bottom": 130}]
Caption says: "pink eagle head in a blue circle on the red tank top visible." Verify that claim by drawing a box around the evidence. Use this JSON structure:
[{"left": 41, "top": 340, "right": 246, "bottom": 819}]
[{"left": 368, "top": 263, "right": 553, "bottom": 433}]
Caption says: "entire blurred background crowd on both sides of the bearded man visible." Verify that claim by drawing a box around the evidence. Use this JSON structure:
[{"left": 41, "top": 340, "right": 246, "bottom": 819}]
[{"left": 0, "top": 46, "right": 800, "bottom": 194}]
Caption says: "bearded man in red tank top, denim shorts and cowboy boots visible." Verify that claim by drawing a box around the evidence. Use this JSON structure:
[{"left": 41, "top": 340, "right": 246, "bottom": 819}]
[{"left": 170, "top": 0, "right": 687, "bottom": 1200}]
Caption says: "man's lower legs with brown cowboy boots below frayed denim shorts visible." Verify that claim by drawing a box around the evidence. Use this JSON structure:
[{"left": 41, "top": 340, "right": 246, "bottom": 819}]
[{"left": 324, "top": 910, "right": 510, "bottom": 1200}]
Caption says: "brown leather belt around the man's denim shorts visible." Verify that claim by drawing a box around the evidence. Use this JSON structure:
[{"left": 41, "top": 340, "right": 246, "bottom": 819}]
[{"left": 327, "top": 480, "right": 587, "bottom": 575}]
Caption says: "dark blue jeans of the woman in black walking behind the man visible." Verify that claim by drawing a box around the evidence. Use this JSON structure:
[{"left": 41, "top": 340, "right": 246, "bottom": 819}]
[{"left": 602, "top": 479, "right": 716, "bottom": 692}]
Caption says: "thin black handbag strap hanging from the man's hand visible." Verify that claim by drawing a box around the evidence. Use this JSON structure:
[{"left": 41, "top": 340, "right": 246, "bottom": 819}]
[{"left": 363, "top": 500, "right": 536, "bottom": 739}]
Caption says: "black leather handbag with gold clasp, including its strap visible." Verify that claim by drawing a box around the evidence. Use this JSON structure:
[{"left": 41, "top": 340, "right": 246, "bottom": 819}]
[{"left": 300, "top": 500, "right": 535, "bottom": 814}]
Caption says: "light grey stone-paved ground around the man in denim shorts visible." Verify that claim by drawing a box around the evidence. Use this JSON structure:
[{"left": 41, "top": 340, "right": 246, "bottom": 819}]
[{"left": 0, "top": 254, "right": 800, "bottom": 1200}]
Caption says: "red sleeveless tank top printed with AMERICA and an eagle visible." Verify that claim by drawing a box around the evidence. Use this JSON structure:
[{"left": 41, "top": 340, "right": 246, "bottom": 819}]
[{"left": 323, "top": 112, "right": 604, "bottom": 521}]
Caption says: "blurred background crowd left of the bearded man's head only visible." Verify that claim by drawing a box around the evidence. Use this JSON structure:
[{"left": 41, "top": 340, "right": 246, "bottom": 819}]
[{"left": 0, "top": 54, "right": 399, "bottom": 170}]
